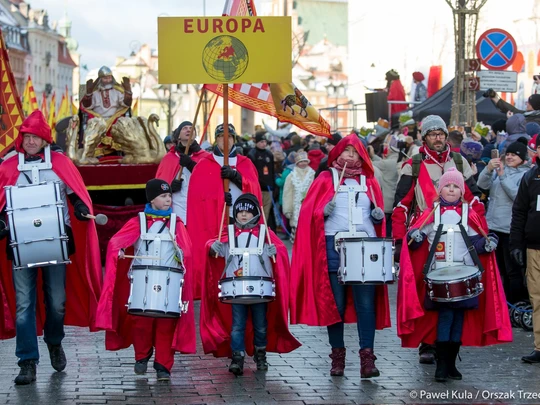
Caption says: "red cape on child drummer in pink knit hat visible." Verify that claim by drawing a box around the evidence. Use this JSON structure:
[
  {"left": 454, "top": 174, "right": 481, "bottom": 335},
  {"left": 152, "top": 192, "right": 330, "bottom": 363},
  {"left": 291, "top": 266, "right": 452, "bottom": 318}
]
[{"left": 397, "top": 204, "right": 512, "bottom": 347}]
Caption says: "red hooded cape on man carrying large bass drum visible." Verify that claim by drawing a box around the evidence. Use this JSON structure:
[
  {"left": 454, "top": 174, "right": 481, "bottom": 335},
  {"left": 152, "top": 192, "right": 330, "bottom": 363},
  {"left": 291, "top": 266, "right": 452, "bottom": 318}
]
[{"left": 0, "top": 110, "right": 102, "bottom": 383}]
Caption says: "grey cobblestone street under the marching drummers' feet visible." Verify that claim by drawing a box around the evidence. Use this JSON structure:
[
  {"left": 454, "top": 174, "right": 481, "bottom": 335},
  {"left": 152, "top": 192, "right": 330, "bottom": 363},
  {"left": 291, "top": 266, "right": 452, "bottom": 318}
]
[{"left": 0, "top": 285, "right": 540, "bottom": 405}]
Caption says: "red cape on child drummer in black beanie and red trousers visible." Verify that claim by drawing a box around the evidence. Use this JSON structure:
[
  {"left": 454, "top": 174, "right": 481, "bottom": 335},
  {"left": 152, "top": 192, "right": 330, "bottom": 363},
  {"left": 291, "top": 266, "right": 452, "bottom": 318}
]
[{"left": 96, "top": 216, "right": 196, "bottom": 353}]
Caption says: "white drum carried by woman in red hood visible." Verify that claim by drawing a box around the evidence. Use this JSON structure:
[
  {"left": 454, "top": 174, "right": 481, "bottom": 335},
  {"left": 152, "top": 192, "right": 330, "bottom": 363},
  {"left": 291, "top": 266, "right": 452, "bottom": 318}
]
[{"left": 335, "top": 238, "right": 395, "bottom": 284}]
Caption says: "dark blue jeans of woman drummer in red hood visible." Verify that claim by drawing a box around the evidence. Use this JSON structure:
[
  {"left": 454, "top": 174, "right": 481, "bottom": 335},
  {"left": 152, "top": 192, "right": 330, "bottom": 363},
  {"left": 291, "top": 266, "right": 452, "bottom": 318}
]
[{"left": 327, "top": 272, "right": 375, "bottom": 349}]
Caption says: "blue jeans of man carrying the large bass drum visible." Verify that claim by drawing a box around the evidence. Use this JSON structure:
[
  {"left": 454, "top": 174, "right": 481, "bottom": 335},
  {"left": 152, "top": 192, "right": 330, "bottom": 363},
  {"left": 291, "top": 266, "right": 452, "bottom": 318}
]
[{"left": 13, "top": 264, "right": 66, "bottom": 363}]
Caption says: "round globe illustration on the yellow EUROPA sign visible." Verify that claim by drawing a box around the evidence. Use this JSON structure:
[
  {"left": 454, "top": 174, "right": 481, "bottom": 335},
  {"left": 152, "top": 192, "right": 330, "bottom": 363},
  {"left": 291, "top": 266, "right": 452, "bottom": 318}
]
[{"left": 202, "top": 35, "right": 249, "bottom": 83}]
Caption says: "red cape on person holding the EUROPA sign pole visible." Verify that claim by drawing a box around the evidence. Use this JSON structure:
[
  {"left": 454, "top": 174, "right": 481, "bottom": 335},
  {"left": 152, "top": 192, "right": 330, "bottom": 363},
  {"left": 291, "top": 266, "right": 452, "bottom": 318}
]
[{"left": 187, "top": 154, "right": 262, "bottom": 299}]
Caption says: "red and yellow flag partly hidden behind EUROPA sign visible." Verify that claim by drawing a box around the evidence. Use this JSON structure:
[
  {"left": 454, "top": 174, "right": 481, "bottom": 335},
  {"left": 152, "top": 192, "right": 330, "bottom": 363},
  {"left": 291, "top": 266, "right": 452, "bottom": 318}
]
[{"left": 204, "top": 0, "right": 331, "bottom": 138}]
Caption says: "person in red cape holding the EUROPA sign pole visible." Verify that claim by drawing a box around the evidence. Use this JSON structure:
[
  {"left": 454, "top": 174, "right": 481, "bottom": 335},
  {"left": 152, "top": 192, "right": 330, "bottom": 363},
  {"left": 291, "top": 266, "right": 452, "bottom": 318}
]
[{"left": 187, "top": 124, "right": 262, "bottom": 299}]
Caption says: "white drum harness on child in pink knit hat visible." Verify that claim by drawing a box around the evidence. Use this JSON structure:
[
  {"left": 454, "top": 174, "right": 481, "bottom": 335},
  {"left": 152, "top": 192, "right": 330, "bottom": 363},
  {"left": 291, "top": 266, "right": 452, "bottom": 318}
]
[{"left": 424, "top": 204, "right": 484, "bottom": 277}]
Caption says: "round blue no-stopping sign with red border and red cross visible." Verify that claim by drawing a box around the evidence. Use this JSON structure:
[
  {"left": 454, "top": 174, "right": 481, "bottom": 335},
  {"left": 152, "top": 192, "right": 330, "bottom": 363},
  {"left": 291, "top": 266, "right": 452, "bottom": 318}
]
[{"left": 476, "top": 28, "right": 517, "bottom": 70}]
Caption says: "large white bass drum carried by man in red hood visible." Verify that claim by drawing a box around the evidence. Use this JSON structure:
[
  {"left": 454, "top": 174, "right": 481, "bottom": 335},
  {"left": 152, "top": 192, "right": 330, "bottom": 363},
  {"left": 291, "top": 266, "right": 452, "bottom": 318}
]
[{"left": 5, "top": 182, "right": 71, "bottom": 269}]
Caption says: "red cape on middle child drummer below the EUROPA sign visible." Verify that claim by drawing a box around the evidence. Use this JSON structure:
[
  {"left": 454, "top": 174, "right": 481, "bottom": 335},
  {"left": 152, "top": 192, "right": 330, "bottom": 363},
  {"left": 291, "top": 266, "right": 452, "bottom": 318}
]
[{"left": 200, "top": 227, "right": 301, "bottom": 357}]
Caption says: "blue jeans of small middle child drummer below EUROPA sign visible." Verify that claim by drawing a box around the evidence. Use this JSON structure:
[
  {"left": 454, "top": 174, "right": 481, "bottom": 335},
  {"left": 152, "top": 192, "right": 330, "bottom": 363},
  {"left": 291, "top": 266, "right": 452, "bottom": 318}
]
[{"left": 231, "top": 302, "right": 268, "bottom": 352}]
